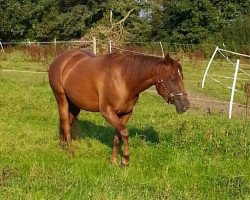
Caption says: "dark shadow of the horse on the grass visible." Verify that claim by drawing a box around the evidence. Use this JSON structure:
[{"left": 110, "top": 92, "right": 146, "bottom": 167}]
[{"left": 72, "top": 120, "right": 159, "bottom": 148}]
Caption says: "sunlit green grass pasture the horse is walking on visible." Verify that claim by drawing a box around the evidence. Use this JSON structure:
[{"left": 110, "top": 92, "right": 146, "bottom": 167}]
[{"left": 0, "top": 49, "right": 250, "bottom": 200}]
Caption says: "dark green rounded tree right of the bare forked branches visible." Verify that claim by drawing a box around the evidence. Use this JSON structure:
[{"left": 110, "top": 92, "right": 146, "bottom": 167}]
[{"left": 149, "top": 0, "right": 219, "bottom": 44}]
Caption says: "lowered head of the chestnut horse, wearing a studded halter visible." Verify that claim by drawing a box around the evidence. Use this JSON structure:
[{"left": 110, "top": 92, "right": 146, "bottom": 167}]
[{"left": 155, "top": 54, "right": 190, "bottom": 113}]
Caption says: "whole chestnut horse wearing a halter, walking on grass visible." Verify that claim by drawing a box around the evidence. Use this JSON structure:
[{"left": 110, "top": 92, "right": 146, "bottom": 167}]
[{"left": 48, "top": 50, "right": 190, "bottom": 165}]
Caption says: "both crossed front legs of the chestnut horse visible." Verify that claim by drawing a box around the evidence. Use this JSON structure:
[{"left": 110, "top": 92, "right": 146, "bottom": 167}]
[{"left": 101, "top": 107, "right": 131, "bottom": 165}]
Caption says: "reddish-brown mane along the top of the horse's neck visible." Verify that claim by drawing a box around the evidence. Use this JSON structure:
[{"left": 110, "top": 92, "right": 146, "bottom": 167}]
[{"left": 106, "top": 53, "right": 163, "bottom": 78}]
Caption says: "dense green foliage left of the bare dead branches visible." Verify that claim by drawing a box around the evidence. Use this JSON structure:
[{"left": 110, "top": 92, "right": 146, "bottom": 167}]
[{"left": 0, "top": 0, "right": 106, "bottom": 41}]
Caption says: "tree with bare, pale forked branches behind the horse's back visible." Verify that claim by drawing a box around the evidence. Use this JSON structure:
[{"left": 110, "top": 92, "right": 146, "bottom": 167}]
[{"left": 82, "top": 0, "right": 150, "bottom": 46}]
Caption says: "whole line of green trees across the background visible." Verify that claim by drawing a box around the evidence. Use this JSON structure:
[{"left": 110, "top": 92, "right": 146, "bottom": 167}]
[{"left": 0, "top": 0, "right": 250, "bottom": 48}]
